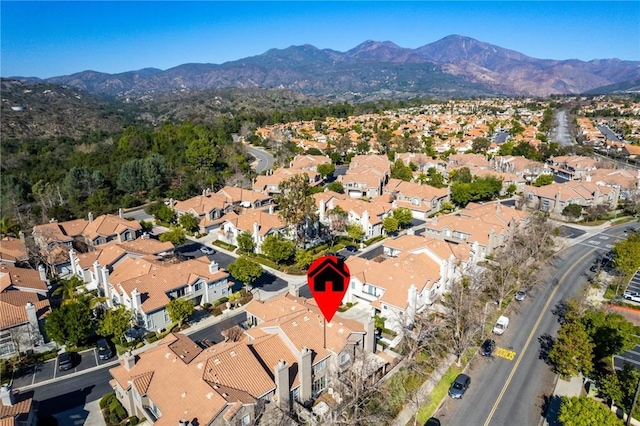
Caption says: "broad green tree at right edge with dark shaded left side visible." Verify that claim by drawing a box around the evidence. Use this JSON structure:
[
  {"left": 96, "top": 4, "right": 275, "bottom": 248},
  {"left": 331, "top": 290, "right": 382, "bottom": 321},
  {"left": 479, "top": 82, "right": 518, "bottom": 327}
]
[{"left": 581, "top": 310, "right": 640, "bottom": 360}]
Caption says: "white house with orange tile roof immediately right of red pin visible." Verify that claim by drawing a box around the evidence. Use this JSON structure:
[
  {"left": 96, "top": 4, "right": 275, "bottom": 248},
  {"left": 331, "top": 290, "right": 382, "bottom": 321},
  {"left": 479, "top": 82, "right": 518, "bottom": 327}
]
[{"left": 344, "top": 253, "right": 445, "bottom": 332}]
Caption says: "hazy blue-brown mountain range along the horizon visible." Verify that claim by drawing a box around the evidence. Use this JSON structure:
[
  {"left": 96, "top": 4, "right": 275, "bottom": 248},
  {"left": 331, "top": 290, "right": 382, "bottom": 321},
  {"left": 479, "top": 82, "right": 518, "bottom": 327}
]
[{"left": 13, "top": 35, "right": 640, "bottom": 101}]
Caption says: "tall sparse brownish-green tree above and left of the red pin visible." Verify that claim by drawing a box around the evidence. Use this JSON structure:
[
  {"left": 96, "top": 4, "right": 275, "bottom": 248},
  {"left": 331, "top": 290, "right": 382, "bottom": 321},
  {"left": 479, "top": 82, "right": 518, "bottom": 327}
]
[{"left": 274, "top": 173, "right": 316, "bottom": 244}]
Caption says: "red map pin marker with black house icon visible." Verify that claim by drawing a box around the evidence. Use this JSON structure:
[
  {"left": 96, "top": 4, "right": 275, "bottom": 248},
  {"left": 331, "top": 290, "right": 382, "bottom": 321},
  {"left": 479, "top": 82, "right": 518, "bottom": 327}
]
[{"left": 307, "top": 256, "right": 351, "bottom": 322}]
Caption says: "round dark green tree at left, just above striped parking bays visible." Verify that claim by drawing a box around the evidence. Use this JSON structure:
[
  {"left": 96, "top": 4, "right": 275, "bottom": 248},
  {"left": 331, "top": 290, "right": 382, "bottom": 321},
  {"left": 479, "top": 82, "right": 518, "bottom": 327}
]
[{"left": 44, "top": 301, "right": 91, "bottom": 346}]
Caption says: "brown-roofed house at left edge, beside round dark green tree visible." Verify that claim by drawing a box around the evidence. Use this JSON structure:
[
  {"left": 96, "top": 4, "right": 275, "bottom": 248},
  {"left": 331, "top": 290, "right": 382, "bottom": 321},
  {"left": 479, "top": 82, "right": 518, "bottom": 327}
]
[{"left": 0, "top": 264, "right": 51, "bottom": 357}]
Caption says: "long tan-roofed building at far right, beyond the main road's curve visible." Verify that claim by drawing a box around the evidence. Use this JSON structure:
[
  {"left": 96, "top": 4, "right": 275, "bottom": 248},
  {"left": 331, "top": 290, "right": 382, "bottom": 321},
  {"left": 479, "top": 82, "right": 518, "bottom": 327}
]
[{"left": 522, "top": 181, "right": 620, "bottom": 214}]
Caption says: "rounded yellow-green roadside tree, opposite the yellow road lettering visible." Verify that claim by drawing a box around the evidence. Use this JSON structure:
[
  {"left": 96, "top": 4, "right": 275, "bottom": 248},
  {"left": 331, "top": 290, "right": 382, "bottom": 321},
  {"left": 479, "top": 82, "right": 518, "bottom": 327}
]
[{"left": 549, "top": 322, "right": 593, "bottom": 378}]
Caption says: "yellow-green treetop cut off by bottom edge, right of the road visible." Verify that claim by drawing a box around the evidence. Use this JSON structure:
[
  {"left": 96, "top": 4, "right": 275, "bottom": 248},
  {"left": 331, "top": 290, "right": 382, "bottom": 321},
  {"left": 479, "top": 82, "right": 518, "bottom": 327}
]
[{"left": 558, "top": 396, "right": 622, "bottom": 426}]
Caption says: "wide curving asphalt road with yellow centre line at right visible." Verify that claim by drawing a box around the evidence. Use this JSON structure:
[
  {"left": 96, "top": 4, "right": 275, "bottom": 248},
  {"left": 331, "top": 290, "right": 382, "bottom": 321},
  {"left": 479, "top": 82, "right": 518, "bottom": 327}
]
[{"left": 436, "top": 224, "right": 637, "bottom": 426}]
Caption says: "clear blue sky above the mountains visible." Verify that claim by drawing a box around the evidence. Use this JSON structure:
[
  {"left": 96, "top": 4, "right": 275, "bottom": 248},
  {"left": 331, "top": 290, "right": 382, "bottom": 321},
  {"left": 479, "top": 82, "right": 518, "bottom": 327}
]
[{"left": 0, "top": 1, "right": 640, "bottom": 78}]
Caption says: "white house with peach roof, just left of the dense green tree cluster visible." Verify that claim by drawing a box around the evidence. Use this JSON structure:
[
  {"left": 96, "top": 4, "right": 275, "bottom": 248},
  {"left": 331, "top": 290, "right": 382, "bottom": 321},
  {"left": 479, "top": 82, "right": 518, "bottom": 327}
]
[{"left": 384, "top": 179, "right": 449, "bottom": 219}]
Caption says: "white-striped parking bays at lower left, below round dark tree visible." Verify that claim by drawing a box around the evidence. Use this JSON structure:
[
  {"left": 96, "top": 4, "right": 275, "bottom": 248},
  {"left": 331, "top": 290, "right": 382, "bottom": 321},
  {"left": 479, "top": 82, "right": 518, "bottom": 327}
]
[{"left": 13, "top": 348, "right": 117, "bottom": 389}]
